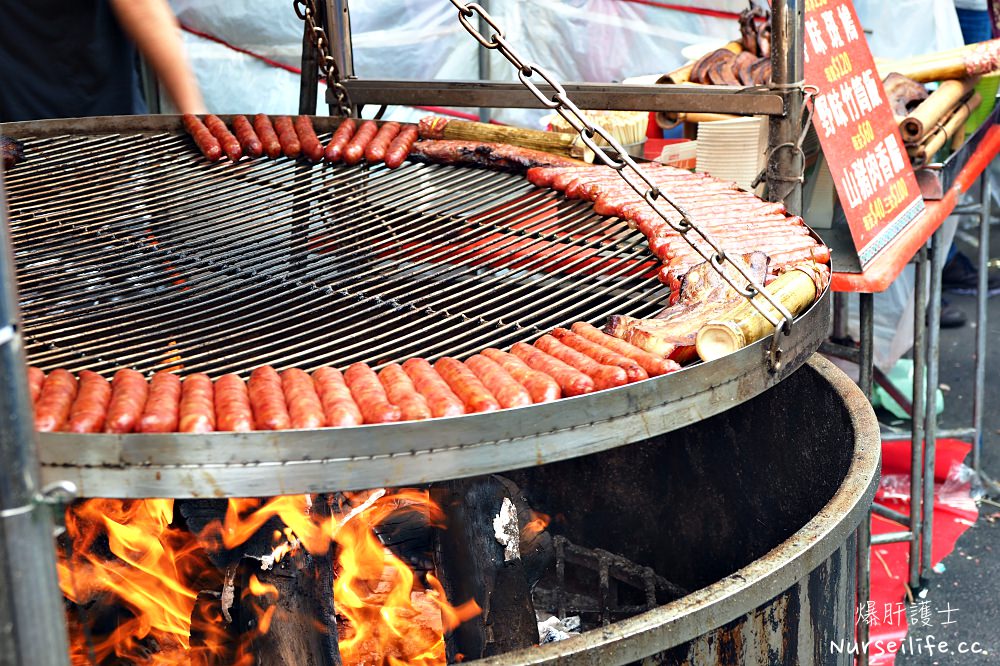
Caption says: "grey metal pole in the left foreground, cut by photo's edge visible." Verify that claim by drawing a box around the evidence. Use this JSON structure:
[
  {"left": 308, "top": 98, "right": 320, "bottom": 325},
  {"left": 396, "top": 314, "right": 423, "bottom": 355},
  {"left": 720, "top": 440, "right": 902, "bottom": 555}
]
[{"left": 0, "top": 171, "right": 69, "bottom": 666}]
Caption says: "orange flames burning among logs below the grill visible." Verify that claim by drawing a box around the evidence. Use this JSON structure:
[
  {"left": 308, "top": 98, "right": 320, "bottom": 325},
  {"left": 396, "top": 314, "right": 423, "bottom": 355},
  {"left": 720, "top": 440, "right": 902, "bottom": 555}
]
[{"left": 58, "top": 489, "right": 480, "bottom": 666}]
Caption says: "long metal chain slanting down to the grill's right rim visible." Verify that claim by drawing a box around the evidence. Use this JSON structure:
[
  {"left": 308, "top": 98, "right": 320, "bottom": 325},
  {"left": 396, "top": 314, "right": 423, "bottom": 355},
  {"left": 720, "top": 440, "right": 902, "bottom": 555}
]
[{"left": 451, "top": 0, "right": 792, "bottom": 334}]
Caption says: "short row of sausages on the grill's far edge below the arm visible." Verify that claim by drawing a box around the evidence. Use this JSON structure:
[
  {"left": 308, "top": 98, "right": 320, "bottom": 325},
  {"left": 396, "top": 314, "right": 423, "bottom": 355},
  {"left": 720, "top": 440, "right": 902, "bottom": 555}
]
[{"left": 183, "top": 113, "right": 417, "bottom": 169}]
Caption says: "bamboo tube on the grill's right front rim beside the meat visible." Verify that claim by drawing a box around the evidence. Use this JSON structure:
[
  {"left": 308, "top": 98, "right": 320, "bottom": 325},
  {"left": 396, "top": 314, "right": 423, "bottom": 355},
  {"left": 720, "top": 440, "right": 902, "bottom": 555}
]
[{"left": 695, "top": 268, "right": 819, "bottom": 361}]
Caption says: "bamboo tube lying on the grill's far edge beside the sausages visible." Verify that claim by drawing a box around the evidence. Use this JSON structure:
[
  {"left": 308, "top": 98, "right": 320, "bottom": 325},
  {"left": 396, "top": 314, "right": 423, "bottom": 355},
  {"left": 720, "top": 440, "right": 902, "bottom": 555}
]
[{"left": 420, "top": 118, "right": 594, "bottom": 162}]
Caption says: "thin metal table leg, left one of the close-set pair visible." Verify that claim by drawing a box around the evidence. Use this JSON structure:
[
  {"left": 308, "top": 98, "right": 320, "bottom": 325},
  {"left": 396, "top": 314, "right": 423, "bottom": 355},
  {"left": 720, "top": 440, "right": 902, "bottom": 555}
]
[{"left": 909, "top": 248, "right": 928, "bottom": 589}]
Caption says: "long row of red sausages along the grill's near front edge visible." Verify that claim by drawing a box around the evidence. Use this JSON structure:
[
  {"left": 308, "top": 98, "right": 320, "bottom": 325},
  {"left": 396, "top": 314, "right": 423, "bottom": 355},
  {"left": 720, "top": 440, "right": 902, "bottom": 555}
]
[{"left": 28, "top": 322, "right": 679, "bottom": 433}]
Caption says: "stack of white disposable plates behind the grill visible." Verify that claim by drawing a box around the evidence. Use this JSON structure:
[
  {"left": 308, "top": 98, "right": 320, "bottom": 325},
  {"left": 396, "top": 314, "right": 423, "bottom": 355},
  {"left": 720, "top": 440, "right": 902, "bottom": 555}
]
[{"left": 695, "top": 118, "right": 767, "bottom": 190}]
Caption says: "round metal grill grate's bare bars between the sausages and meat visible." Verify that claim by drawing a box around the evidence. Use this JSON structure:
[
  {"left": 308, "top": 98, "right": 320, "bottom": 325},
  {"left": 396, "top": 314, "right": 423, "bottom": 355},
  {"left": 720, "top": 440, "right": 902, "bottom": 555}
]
[{"left": 5, "top": 132, "right": 666, "bottom": 376}]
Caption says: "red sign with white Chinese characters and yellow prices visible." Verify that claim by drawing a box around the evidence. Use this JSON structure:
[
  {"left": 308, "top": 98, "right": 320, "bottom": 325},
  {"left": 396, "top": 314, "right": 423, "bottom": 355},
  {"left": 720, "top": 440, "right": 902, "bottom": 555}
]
[{"left": 803, "top": 0, "right": 924, "bottom": 268}]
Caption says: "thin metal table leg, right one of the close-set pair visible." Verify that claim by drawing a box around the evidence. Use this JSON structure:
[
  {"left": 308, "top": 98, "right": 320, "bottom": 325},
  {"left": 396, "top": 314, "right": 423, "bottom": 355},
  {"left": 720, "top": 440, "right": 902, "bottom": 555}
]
[{"left": 920, "top": 230, "right": 948, "bottom": 574}]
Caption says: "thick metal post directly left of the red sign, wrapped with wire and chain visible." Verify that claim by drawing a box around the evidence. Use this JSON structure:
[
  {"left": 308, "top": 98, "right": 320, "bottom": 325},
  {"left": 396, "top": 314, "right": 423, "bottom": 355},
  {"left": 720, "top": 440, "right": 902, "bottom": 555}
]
[{"left": 767, "top": 0, "right": 805, "bottom": 214}]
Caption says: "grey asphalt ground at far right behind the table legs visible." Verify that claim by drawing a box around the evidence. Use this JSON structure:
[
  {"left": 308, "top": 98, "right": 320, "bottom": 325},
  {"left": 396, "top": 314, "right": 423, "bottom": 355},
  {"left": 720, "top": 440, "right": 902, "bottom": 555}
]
[{"left": 896, "top": 226, "right": 1000, "bottom": 666}]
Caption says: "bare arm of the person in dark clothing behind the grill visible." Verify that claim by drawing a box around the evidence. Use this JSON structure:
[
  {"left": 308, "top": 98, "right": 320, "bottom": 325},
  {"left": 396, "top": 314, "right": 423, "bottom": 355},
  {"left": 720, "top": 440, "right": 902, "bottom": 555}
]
[{"left": 110, "top": 0, "right": 206, "bottom": 113}]
